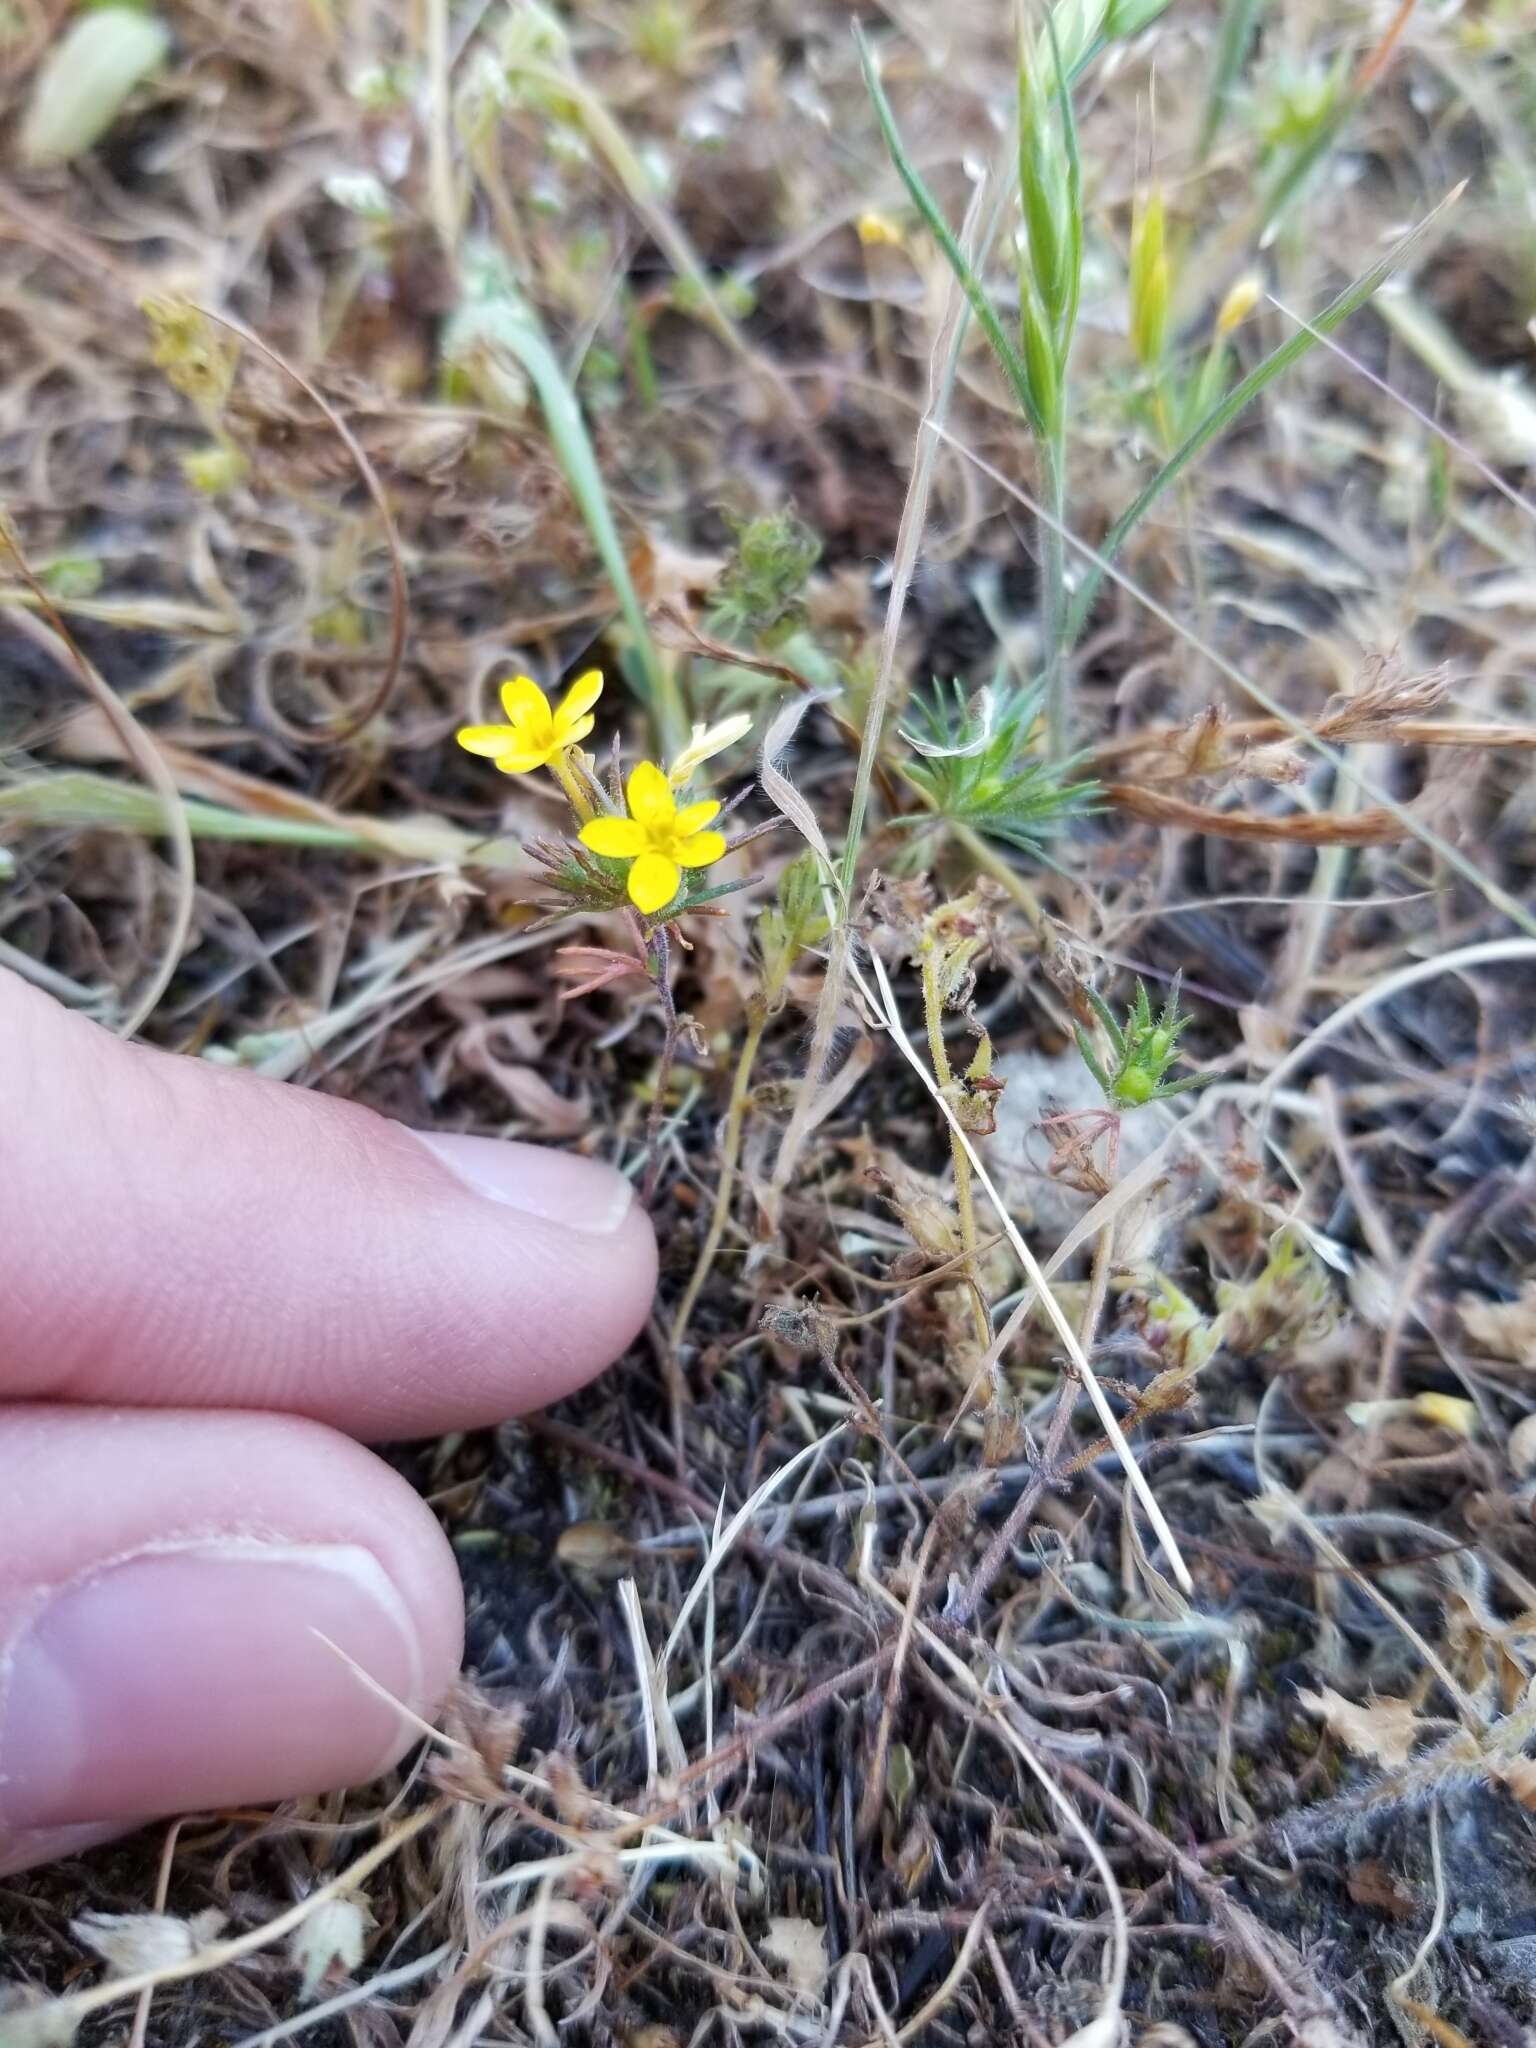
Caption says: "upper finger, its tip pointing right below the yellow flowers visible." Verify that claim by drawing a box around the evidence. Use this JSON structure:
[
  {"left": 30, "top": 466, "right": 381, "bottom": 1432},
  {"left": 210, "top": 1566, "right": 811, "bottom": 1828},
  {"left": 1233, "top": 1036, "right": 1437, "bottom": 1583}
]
[{"left": 0, "top": 975, "right": 657, "bottom": 1438}]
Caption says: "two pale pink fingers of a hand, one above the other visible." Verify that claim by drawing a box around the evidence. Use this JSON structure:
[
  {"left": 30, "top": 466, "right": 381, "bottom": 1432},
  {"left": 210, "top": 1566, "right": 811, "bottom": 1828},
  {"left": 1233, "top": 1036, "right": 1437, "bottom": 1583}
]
[{"left": 0, "top": 973, "right": 655, "bottom": 1872}]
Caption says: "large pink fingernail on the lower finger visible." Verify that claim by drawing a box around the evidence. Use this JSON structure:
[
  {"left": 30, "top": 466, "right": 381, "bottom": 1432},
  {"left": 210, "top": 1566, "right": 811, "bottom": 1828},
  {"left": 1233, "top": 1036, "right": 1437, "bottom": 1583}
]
[{"left": 0, "top": 1540, "right": 424, "bottom": 1833}]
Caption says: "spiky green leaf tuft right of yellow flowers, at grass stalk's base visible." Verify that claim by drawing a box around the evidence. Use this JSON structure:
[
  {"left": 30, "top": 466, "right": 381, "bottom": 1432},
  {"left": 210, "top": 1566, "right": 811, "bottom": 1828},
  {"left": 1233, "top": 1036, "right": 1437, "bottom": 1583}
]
[{"left": 899, "top": 682, "right": 1098, "bottom": 854}]
